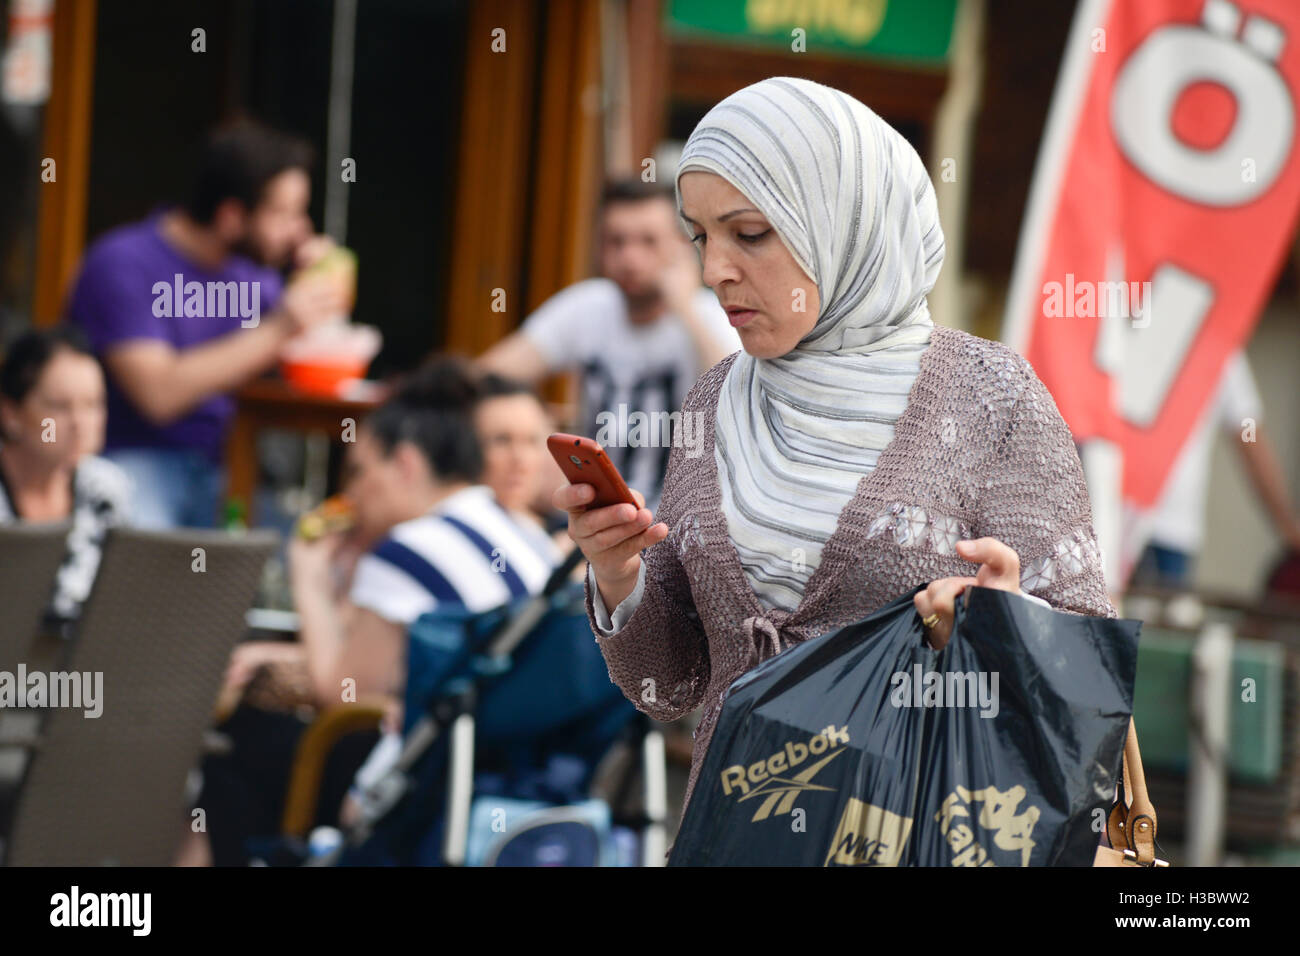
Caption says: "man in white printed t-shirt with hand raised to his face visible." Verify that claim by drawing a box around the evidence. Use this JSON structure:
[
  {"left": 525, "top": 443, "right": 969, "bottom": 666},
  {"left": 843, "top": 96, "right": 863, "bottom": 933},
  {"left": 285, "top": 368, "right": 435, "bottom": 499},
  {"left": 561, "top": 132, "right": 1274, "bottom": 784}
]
[{"left": 480, "top": 179, "right": 741, "bottom": 510}]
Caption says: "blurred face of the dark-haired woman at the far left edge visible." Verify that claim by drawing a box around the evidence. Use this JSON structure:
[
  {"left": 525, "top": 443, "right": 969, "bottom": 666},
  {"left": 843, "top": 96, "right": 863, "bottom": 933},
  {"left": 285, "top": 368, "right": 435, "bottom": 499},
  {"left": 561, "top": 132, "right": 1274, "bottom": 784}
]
[{"left": 4, "top": 349, "right": 107, "bottom": 467}]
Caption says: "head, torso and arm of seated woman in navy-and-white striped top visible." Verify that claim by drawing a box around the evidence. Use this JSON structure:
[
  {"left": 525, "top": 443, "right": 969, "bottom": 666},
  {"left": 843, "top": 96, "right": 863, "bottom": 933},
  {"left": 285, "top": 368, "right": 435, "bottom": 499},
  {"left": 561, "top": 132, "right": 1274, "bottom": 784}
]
[{"left": 290, "top": 360, "right": 560, "bottom": 705}]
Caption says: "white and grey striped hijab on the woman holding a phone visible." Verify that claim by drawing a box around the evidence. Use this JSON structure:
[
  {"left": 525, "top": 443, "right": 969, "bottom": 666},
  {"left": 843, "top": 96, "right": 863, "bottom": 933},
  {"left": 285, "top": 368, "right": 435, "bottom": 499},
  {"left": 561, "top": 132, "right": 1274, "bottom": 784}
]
[{"left": 677, "top": 77, "right": 944, "bottom": 610}]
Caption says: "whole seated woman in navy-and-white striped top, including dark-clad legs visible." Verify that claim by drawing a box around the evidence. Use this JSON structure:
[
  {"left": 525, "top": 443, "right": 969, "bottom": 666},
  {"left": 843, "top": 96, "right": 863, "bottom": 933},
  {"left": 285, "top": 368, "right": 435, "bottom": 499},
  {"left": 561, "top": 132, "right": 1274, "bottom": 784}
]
[{"left": 191, "top": 359, "right": 562, "bottom": 866}]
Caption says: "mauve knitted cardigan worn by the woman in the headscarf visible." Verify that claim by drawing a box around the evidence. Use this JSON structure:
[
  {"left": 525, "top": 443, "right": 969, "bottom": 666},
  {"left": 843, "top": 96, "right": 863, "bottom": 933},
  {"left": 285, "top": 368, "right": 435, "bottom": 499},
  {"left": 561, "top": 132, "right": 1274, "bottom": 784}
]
[{"left": 586, "top": 326, "right": 1118, "bottom": 812}]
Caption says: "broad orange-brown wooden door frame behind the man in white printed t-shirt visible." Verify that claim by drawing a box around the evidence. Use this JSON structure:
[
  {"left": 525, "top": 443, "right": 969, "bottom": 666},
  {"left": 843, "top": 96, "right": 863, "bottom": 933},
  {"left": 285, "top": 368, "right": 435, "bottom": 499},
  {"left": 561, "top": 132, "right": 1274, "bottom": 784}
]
[{"left": 443, "top": 0, "right": 605, "bottom": 416}]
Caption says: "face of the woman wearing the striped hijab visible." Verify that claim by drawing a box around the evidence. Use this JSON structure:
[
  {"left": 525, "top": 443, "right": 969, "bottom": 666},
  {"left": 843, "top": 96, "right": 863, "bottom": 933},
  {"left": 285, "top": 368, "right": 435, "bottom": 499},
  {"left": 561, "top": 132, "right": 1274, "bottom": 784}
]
[{"left": 679, "top": 169, "right": 822, "bottom": 359}]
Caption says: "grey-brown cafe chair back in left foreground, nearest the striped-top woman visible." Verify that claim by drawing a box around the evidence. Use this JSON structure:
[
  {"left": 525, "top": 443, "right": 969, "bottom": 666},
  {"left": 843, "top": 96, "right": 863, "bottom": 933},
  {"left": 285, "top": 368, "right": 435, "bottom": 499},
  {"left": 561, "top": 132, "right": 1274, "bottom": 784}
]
[{"left": 5, "top": 529, "right": 277, "bottom": 866}]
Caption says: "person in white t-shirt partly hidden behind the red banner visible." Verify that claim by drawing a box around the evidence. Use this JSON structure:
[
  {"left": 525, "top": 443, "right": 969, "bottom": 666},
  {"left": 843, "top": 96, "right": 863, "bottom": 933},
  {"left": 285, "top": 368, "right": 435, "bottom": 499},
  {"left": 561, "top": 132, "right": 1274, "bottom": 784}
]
[{"left": 1130, "top": 351, "right": 1300, "bottom": 587}]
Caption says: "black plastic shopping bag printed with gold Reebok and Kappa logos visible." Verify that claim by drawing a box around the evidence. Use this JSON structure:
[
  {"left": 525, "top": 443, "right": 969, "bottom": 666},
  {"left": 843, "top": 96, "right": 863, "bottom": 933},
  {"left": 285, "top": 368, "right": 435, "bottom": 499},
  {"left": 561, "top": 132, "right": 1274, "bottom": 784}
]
[{"left": 668, "top": 587, "right": 1141, "bottom": 866}]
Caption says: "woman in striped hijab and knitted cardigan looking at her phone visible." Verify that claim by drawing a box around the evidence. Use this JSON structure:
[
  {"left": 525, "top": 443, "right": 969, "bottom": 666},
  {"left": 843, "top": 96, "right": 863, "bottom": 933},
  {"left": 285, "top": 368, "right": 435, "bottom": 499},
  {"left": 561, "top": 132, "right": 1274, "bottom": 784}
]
[{"left": 555, "top": 77, "right": 1115, "bottom": 822}]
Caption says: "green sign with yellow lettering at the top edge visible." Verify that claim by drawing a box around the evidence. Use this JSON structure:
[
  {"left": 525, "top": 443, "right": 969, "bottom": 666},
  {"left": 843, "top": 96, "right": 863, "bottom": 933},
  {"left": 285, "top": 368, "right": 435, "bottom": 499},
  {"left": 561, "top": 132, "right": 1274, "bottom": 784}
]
[{"left": 667, "top": 0, "right": 958, "bottom": 65}]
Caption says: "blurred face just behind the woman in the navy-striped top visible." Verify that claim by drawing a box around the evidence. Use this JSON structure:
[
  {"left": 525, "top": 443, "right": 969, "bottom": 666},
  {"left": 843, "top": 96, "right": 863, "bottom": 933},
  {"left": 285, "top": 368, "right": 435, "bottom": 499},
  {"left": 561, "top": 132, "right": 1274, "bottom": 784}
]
[{"left": 475, "top": 395, "right": 550, "bottom": 510}]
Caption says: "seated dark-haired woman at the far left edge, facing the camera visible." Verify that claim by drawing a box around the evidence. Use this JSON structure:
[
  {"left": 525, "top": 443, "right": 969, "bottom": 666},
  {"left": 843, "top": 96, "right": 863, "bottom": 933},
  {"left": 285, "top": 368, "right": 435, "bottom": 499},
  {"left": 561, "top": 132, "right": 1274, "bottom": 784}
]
[{"left": 0, "top": 328, "right": 131, "bottom": 624}]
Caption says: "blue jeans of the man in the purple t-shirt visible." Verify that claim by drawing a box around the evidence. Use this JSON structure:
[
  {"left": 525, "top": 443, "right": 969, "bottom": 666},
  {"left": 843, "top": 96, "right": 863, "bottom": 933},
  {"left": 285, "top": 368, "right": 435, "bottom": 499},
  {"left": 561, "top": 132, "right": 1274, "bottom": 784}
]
[{"left": 104, "top": 449, "right": 225, "bottom": 531}]
